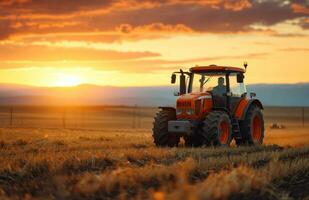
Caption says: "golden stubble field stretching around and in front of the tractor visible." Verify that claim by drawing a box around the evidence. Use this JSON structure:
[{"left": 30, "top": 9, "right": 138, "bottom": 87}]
[{"left": 0, "top": 109, "right": 309, "bottom": 200}]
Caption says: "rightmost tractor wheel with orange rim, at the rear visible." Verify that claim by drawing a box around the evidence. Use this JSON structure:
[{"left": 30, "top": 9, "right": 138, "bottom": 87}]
[{"left": 236, "top": 105, "right": 264, "bottom": 146}]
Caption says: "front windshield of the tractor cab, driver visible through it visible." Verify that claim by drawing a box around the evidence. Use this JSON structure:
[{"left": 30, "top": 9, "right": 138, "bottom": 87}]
[{"left": 192, "top": 74, "right": 226, "bottom": 96}]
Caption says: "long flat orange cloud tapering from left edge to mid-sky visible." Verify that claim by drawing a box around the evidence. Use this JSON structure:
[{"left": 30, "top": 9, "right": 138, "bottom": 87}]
[{"left": 0, "top": 44, "right": 160, "bottom": 62}]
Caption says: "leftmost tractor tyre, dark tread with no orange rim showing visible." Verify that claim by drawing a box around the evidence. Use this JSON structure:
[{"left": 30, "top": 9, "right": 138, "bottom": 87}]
[{"left": 152, "top": 110, "right": 180, "bottom": 147}]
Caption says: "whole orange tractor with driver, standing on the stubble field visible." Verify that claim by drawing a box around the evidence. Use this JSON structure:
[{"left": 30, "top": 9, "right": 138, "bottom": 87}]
[{"left": 153, "top": 63, "right": 264, "bottom": 147}]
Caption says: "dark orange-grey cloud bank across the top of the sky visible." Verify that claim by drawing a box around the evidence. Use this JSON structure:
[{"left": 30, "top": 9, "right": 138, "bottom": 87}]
[{"left": 0, "top": 0, "right": 309, "bottom": 42}]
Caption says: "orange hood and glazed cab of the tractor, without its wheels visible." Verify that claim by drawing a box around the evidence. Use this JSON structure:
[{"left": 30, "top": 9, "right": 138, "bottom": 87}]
[{"left": 172, "top": 65, "right": 247, "bottom": 120}]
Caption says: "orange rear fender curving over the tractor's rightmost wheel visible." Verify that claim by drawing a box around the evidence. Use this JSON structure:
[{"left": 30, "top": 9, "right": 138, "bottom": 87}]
[{"left": 235, "top": 99, "right": 264, "bottom": 120}]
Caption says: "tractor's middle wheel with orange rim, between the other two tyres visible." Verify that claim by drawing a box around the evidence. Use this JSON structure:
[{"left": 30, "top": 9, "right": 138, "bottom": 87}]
[{"left": 201, "top": 111, "right": 232, "bottom": 146}]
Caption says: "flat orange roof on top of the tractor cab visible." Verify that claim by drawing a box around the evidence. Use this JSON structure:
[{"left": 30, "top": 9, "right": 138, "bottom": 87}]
[{"left": 190, "top": 65, "right": 245, "bottom": 73}]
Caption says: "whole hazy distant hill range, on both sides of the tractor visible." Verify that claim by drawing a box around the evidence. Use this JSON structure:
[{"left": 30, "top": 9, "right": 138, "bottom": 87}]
[{"left": 0, "top": 83, "right": 309, "bottom": 106}]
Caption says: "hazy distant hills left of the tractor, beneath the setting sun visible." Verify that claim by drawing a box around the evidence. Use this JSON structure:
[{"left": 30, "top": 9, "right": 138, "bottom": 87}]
[{"left": 0, "top": 84, "right": 176, "bottom": 106}]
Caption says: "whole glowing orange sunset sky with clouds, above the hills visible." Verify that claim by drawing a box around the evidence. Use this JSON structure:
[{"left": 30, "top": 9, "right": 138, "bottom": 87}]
[{"left": 0, "top": 0, "right": 309, "bottom": 86}]
